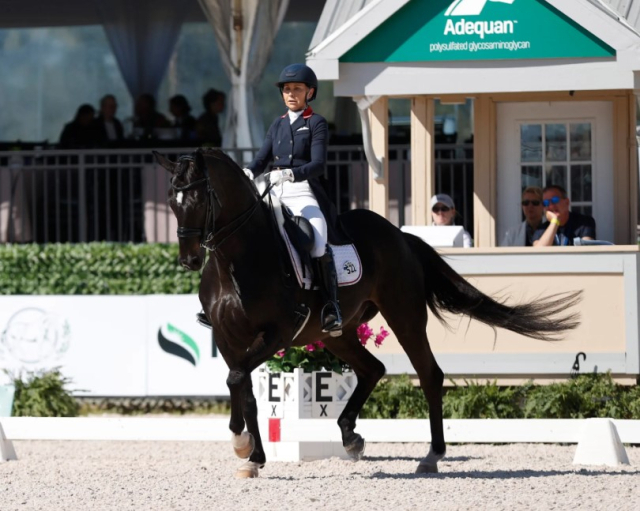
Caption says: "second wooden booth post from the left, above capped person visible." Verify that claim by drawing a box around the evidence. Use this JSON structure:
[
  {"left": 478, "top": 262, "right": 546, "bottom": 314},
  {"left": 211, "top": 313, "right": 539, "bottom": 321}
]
[{"left": 411, "top": 96, "right": 436, "bottom": 225}]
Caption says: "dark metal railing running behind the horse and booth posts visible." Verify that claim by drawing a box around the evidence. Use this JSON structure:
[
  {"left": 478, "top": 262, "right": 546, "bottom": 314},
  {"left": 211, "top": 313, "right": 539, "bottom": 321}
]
[{"left": 0, "top": 145, "right": 473, "bottom": 243}]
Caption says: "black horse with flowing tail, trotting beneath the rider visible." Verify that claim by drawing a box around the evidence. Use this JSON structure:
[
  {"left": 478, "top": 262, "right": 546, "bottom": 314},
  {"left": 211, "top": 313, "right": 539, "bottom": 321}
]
[{"left": 155, "top": 149, "right": 580, "bottom": 477}]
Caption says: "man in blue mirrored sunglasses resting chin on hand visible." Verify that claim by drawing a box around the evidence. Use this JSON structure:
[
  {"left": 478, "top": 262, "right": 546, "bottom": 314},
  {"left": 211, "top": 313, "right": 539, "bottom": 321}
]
[{"left": 533, "top": 185, "right": 596, "bottom": 247}]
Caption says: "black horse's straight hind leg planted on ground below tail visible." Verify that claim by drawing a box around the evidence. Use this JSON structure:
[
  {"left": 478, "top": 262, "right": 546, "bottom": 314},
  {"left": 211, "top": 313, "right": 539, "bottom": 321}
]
[{"left": 380, "top": 300, "right": 446, "bottom": 473}]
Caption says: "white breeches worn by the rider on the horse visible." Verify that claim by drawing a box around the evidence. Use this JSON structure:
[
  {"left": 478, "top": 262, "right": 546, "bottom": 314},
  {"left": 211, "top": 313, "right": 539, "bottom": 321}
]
[{"left": 271, "top": 181, "right": 327, "bottom": 257}]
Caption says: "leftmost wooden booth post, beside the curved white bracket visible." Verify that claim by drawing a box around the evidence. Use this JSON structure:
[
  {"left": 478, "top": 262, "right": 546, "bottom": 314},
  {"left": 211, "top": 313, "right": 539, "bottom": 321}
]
[{"left": 369, "top": 97, "right": 389, "bottom": 218}]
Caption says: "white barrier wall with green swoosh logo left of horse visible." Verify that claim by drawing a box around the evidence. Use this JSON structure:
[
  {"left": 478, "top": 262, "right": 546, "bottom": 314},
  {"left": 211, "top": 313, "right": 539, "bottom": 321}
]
[{"left": 0, "top": 295, "right": 229, "bottom": 396}]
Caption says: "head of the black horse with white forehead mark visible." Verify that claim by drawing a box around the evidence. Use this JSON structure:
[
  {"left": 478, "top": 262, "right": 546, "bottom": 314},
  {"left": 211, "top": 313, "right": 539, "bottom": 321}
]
[{"left": 153, "top": 151, "right": 209, "bottom": 271}]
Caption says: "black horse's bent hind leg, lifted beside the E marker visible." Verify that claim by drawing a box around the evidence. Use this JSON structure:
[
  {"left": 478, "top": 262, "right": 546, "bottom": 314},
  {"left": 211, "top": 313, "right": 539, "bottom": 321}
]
[{"left": 327, "top": 328, "right": 385, "bottom": 461}]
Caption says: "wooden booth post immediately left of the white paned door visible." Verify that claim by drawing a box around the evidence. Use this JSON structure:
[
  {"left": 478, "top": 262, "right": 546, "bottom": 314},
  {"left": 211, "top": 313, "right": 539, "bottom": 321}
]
[{"left": 473, "top": 95, "right": 497, "bottom": 248}]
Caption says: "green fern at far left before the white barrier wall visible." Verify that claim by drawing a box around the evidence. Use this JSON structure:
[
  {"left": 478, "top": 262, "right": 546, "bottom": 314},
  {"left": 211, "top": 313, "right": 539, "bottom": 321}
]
[{"left": 12, "top": 369, "right": 80, "bottom": 417}]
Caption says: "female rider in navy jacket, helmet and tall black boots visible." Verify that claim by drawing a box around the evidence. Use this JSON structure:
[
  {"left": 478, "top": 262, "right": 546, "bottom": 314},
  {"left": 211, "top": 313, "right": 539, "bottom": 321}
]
[{"left": 244, "top": 64, "right": 342, "bottom": 335}]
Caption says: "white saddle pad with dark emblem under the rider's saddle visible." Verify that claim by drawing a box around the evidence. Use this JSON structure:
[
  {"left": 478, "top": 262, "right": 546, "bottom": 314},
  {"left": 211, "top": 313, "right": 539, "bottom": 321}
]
[{"left": 273, "top": 189, "right": 362, "bottom": 289}]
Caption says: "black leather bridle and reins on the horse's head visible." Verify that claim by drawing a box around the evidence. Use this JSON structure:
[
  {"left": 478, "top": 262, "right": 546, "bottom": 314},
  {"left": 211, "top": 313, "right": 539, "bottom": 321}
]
[{"left": 171, "top": 156, "right": 273, "bottom": 252}]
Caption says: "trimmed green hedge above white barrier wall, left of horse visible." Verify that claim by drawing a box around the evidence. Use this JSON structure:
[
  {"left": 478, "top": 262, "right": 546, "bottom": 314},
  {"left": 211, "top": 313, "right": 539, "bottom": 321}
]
[{"left": 0, "top": 243, "right": 200, "bottom": 295}]
